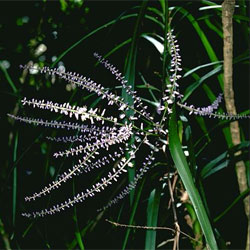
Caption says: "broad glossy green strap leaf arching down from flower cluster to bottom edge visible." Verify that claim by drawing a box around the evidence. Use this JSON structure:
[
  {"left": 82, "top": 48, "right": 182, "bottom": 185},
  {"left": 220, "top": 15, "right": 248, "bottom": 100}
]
[{"left": 169, "top": 107, "right": 218, "bottom": 250}]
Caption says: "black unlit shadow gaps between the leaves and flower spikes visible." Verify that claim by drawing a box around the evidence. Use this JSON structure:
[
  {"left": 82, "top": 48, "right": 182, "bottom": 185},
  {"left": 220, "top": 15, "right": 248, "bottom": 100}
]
[{"left": 0, "top": 1, "right": 249, "bottom": 249}]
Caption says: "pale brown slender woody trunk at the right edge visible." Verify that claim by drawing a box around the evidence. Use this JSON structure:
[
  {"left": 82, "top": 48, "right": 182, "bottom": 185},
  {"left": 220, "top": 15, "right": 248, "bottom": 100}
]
[{"left": 222, "top": 0, "right": 250, "bottom": 250}]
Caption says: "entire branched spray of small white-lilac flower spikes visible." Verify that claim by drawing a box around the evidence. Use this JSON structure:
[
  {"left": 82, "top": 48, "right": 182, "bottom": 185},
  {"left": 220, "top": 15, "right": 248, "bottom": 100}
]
[{"left": 8, "top": 30, "right": 249, "bottom": 217}]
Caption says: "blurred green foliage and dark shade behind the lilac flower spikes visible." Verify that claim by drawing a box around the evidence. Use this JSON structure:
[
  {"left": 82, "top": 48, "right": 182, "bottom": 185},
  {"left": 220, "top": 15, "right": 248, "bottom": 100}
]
[{"left": 0, "top": 0, "right": 249, "bottom": 249}]
